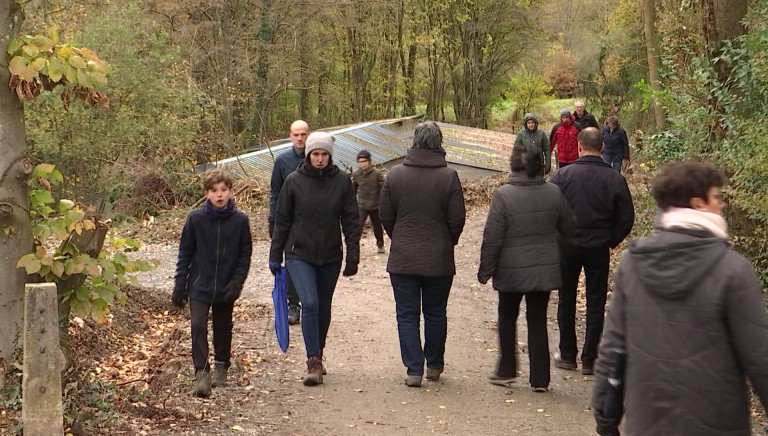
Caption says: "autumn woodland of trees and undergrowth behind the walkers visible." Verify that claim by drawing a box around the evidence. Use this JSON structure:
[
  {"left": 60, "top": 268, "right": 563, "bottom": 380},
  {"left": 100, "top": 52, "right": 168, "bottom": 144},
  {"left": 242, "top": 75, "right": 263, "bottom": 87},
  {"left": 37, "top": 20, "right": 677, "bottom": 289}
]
[{"left": 15, "top": 0, "right": 768, "bottom": 286}]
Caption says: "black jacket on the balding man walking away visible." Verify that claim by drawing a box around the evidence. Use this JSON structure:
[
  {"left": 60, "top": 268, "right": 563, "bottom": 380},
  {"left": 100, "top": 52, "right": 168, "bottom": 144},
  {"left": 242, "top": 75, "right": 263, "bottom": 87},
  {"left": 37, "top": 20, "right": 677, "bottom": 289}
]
[{"left": 550, "top": 156, "right": 635, "bottom": 248}]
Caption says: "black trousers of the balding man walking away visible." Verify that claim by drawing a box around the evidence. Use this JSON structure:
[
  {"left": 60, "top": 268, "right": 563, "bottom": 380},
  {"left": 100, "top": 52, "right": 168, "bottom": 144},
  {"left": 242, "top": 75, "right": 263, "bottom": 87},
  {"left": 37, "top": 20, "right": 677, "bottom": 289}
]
[{"left": 557, "top": 247, "right": 611, "bottom": 364}]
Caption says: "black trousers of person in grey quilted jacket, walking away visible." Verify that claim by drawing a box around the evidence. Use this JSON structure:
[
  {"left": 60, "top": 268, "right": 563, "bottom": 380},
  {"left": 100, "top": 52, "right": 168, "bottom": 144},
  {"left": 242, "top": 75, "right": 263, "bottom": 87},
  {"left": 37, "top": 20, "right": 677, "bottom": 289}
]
[{"left": 496, "top": 291, "right": 549, "bottom": 388}]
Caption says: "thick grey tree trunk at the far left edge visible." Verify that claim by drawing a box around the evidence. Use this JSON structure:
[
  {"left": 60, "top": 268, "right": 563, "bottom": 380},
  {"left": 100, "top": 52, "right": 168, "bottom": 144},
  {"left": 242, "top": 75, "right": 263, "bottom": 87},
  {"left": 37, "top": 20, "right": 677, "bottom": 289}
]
[{"left": 0, "top": 0, "right": 32, "bottom": 368}]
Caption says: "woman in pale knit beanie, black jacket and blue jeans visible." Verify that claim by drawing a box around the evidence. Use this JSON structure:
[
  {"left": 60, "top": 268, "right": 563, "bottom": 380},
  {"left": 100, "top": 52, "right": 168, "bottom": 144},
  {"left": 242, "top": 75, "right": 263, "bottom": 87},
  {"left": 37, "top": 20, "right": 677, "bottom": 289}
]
[{"left": 269, "top": 132, "right": 360, "bottom": 386}]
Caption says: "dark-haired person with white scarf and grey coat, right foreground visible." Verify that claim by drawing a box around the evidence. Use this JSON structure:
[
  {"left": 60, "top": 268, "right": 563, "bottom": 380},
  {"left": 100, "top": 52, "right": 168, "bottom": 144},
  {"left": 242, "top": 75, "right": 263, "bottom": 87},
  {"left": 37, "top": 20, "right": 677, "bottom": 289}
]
[{"left": 591, "top": 162, "right": 768, "bottom": 436}]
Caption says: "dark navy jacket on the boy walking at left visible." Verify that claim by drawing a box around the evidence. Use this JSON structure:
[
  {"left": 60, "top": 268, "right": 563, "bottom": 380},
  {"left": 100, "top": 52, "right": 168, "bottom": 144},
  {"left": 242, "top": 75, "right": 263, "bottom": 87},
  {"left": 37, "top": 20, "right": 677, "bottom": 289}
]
[{"left": 175, "top": 206, "right": 253, "bottom": 304}]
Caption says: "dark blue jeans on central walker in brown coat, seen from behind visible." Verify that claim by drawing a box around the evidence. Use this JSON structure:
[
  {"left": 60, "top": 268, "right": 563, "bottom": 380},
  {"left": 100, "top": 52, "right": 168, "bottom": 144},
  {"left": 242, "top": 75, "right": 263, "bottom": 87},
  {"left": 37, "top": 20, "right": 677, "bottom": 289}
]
[{"left": 389, "top": 273, "right": 453, "bottom": 375}]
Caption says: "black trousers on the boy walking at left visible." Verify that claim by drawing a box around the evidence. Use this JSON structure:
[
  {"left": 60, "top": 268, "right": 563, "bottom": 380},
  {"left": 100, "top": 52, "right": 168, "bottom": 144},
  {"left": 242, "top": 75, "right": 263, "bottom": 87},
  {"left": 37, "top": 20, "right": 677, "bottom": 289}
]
[{"left": 189, "top": 300, "right": 235, "bottom": 370}]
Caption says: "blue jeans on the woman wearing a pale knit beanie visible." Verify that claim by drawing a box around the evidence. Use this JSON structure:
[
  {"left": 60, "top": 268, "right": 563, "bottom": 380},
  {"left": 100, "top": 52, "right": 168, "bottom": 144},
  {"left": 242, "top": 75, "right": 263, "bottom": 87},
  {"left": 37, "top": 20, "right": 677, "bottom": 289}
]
[{"left": 285, "top": 259, "right": 341, "bottom": 357}]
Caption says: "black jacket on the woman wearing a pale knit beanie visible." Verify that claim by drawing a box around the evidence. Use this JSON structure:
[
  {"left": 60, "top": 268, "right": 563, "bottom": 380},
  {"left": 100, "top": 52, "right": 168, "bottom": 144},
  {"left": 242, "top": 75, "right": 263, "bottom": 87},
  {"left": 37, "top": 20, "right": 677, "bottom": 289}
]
[{"left": 269, "top": 162, "right": 360, "bottom": 265}]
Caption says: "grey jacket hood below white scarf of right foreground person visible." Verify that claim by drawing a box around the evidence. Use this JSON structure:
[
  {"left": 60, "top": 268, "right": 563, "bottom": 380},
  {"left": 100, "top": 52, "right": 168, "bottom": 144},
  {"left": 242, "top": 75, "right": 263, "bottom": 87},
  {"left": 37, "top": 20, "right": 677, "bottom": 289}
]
[{"left": 629, "top": 228, "right": 730, "bottom": 300}]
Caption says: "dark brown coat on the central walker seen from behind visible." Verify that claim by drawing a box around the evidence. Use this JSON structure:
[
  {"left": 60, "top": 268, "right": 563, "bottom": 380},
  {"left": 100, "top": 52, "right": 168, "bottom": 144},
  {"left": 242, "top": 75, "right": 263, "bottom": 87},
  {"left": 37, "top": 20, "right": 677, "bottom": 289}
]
[{"left": 379, "top": 149, "right": 466, "bottom": 276}]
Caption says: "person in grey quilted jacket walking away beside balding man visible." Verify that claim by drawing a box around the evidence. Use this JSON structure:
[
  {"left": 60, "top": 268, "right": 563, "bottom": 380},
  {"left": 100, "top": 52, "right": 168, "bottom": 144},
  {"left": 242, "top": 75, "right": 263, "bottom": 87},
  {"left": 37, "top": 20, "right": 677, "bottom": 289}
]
[{"left": 477, "top": 144, "right": 575, "bottom": 392}]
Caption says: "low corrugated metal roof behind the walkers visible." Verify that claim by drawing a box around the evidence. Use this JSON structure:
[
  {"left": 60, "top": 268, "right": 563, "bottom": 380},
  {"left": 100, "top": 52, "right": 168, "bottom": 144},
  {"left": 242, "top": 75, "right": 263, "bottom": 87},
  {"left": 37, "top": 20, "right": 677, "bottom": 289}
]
[{"left": 205, "top": 119, "right": 515, "bottom": 180}]
